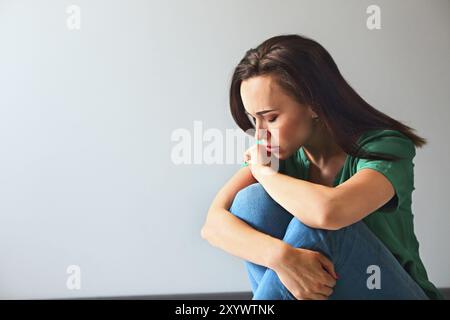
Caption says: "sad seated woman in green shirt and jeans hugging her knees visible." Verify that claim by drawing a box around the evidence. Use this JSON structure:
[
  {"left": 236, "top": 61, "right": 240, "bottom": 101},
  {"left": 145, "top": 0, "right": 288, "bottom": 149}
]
[{"left": 202, "top": 35, "right": 443, "bottom": 300}]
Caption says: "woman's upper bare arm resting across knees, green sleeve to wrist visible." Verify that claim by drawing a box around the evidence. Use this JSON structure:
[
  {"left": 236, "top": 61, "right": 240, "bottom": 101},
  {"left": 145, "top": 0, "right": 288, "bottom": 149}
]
[{"left": 253, "top": 167, "right": 395, "bottom": 230}]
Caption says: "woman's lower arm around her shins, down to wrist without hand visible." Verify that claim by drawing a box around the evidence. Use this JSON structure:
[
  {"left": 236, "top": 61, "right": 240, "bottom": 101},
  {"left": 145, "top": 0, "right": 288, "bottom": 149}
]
[{"left": 201, "top": 167, "right": 288, "bottom": 269}]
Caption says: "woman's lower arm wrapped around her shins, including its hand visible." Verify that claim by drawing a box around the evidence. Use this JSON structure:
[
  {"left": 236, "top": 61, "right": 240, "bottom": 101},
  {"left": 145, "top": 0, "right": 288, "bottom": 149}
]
[{"left": 201, "top": 167, "right": 336, "bottom": 299}]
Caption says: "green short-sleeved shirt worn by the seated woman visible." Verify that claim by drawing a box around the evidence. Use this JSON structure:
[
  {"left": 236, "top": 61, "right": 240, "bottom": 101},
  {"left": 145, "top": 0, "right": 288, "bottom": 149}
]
[{"left": 280, "top": 130, "right": 444, "bottom": 299}]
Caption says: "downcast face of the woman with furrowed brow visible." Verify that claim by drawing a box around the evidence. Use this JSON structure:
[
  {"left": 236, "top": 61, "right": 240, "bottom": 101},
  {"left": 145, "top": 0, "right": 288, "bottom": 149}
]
[{"left": 241, "top": 75, "right": 317, "bottom": 159}]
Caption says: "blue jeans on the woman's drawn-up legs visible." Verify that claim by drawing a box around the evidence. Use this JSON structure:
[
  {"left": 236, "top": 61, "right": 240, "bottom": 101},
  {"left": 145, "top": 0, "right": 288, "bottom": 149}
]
[{"left": 229, "top": 183, "right": 428, "bottom": 300}]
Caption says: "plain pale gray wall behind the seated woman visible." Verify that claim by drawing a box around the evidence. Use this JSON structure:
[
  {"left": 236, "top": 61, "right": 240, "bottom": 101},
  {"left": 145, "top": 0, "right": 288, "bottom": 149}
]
[{"left": 0, "top": 0, "right": 450, "bottom": 298}]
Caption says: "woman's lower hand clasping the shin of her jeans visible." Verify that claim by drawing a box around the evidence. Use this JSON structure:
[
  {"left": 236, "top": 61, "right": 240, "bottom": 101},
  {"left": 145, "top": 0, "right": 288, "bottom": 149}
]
[{"left": 273, "top": 245, "right": 338, "bottom": 300}]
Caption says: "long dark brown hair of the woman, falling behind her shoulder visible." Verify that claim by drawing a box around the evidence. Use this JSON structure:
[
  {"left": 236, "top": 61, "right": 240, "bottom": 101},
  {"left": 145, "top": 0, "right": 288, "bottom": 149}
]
[{"left": 229, "top": 34, "right": 427, "bottom": 161}]
